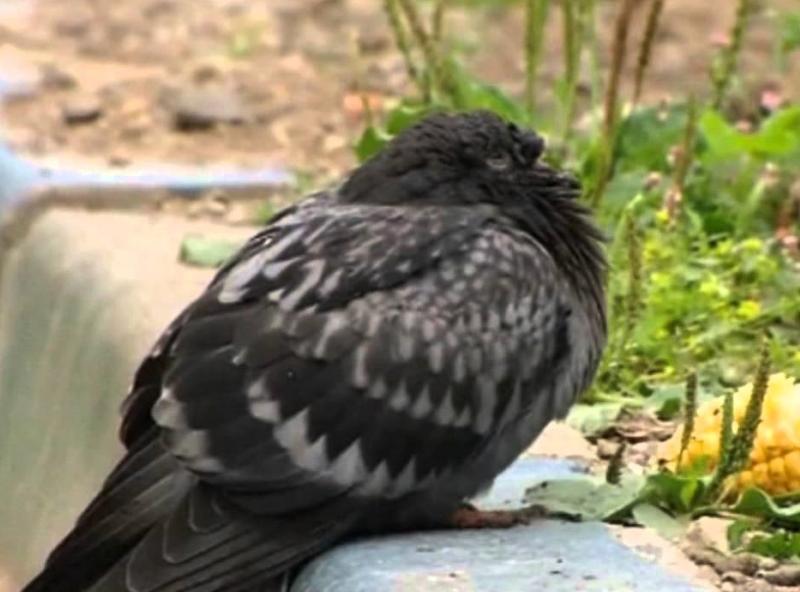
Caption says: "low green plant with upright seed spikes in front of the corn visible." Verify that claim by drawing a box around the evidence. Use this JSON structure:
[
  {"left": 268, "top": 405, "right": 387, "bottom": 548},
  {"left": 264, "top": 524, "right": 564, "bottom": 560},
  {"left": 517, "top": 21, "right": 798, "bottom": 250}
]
[{"left": 526, "top": 352, "right": 800, "bottom": 558}]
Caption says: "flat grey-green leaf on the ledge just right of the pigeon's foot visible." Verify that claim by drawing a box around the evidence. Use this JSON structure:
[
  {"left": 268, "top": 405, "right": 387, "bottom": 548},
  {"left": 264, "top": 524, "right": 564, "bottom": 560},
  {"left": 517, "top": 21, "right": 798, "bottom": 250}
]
[{"left": 525, "top": 474, "right": 644, "bottom": 520}]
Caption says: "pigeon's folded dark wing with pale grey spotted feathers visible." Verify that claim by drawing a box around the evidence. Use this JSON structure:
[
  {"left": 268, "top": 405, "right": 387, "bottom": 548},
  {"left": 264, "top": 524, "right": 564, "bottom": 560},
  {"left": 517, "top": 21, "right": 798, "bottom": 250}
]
[{"left": 155, "top": 206, "right": 567, "bottom": 512}]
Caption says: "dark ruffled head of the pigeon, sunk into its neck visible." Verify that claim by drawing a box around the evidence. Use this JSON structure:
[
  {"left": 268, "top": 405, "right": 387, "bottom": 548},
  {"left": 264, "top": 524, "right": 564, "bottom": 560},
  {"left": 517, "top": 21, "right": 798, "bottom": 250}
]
[{"left": 342, "top": 111, "right": 580, "bottom": 205}]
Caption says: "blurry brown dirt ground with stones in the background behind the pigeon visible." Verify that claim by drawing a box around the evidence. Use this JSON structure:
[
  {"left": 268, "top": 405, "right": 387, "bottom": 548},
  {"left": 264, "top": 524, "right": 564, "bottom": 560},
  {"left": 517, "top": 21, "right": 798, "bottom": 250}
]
[{"left": 0, "top": 0, "right": 800, "bottom": 176}]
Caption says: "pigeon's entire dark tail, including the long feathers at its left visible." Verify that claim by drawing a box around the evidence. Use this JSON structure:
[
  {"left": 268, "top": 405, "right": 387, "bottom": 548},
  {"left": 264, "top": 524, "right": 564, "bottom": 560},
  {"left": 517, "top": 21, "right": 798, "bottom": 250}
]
[{"left": 23, "top": 437, "right": 361, "bottom": 592}]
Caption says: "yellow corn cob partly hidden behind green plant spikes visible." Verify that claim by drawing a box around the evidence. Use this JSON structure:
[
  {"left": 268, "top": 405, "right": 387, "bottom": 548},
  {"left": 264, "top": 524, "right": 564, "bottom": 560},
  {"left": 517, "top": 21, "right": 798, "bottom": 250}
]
[{"left": 657, "top": 373, "right": 800, "bottom": 494}]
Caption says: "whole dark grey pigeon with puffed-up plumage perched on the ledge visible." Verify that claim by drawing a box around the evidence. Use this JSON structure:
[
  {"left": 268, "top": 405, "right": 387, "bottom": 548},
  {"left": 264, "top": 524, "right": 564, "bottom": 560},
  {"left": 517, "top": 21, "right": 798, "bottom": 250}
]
[{"left": 24, "top": 111, "right": 607, "bottom": 592}]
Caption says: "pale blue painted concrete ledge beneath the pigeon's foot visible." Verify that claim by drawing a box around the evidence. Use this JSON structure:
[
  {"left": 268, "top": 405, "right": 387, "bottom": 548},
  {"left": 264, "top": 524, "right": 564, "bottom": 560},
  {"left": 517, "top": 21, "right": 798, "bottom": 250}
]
[{"left": 291, "top": 459, "right": 702, "bottom": 592}]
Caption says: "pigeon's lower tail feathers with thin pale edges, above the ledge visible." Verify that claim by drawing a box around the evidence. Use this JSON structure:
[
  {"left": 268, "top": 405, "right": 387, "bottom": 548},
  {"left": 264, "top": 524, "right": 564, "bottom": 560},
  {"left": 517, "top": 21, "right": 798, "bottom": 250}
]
[{"left": 90, "top": 485, "right": 355, "bottom": 592}]
